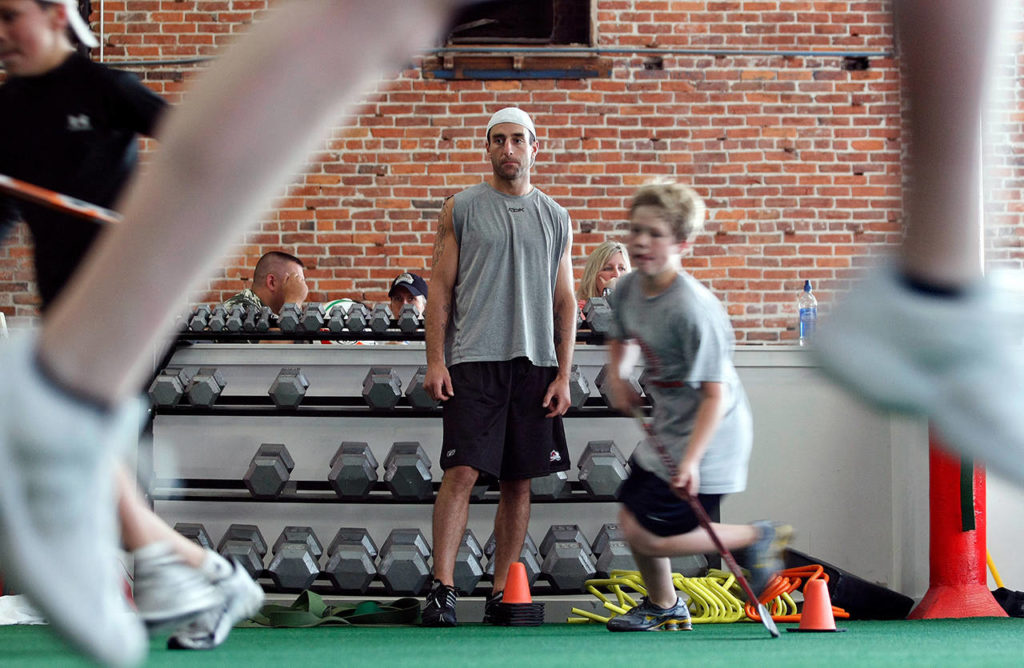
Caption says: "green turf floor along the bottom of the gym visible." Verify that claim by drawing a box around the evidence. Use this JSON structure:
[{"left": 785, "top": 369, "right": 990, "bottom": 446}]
[{"left": 0, "top": 619, "right": 1024, "bottom": 668}]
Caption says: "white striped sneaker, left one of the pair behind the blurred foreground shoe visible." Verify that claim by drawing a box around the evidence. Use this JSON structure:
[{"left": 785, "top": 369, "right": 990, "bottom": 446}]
[{"left": 133, "top": 543, "right": 224, "bottom": 633}]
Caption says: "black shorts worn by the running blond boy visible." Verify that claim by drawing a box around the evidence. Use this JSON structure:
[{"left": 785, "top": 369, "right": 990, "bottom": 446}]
[{"left": 618, "top": 460, "right": 723, "bottom": 536}]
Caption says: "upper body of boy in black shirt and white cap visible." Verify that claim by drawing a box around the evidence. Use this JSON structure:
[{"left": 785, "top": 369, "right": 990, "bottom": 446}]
[{"left": 0, "top": 0, "right": 167, "bottom": 305}]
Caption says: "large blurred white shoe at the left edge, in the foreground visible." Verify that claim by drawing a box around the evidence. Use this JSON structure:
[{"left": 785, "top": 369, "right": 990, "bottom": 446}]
[{"left": 0, "top": 336, "right": 148, "bottom": 666}]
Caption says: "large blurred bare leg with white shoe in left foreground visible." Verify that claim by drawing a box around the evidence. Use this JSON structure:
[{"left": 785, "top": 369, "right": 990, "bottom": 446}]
[{"left": 0, "top": 0, "right": 475, "bottom": 666}]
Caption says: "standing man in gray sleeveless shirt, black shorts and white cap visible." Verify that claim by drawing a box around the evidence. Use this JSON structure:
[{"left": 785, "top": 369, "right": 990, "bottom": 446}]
[{"left": 423, "top": 108, "right": 577, "bottom": 626}]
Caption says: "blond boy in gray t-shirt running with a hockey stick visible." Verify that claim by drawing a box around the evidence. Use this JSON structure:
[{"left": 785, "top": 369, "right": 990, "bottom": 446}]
[{"left": 608, "top": 183, "right": 792, "bottom": 631}]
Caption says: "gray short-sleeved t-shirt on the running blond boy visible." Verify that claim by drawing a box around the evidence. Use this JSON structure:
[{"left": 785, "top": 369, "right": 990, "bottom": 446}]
[{"left": 610, "top": 273, "right": 754, "bottom": 494}]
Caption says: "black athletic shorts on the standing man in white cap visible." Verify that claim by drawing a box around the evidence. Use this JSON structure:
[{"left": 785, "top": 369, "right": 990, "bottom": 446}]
[{"left": 440, "top": 358, "right": 570, "bottom": 481}]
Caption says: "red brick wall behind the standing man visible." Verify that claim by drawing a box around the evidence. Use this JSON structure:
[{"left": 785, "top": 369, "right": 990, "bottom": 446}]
[{"left": 0, "top": 0, "right": 1024, "bottom": 341}]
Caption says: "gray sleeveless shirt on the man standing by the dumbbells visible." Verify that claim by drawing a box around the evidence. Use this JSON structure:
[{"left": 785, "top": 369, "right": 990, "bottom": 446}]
[{"left": 444, "top": 183, "right": 570, "bottom": 367}]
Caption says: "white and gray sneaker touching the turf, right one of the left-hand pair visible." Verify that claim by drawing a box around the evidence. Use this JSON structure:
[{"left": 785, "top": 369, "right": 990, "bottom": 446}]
[{"left": 167, "top": 559, "right": 263, "bottom": 650}]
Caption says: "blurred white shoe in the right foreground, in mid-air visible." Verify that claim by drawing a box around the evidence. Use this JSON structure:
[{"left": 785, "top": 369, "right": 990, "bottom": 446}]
[{"left": 814, "top": 269, "right": 1024, "bottom": 483}]
